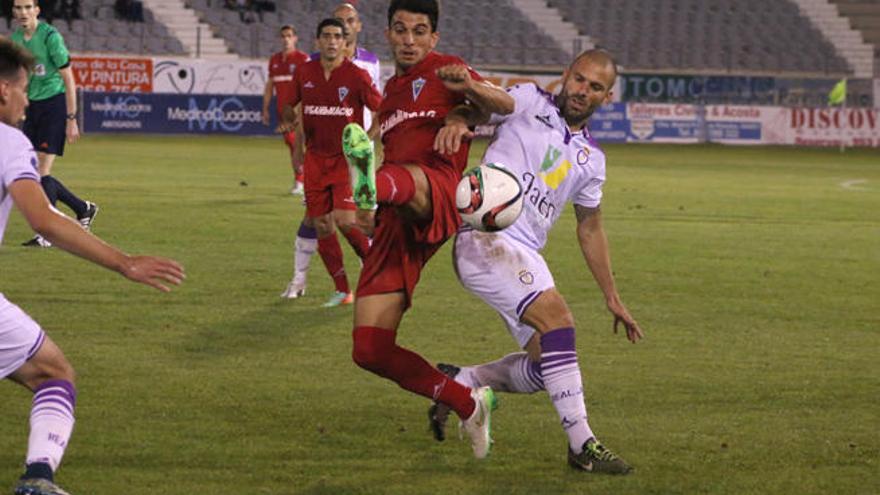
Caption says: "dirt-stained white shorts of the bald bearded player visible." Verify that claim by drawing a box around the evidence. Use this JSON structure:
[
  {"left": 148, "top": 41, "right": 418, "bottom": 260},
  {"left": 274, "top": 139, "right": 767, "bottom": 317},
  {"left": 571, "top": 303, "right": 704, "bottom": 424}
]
[{"left": 452, "top": 230, "right": 556, "bottom": 348}]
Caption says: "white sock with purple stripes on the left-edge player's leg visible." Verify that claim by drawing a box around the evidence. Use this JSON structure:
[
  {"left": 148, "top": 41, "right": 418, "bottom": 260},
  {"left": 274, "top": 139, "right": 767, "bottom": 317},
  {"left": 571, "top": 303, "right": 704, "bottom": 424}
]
[{"left": 26, "top": 380, "right": 76, "bottom": 472}]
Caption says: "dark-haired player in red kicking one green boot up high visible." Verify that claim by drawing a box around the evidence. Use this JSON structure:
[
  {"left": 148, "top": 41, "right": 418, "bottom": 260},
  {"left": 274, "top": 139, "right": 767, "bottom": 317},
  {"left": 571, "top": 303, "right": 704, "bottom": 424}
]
[{"left": 343, "top": 0, "right": 513, "bottom": 458}]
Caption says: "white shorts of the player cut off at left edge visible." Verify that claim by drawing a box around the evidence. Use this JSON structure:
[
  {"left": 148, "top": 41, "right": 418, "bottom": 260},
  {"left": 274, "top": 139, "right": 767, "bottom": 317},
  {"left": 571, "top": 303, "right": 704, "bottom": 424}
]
[{"left": 0, "top": 294, "right": 46, "bottom": 380}]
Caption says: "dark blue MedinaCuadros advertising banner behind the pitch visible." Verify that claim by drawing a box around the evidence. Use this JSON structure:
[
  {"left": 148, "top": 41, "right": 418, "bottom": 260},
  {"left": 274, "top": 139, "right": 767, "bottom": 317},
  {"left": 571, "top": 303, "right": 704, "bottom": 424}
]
[{"left": 83, "top": 93, "right": 277, "bottom": 136}]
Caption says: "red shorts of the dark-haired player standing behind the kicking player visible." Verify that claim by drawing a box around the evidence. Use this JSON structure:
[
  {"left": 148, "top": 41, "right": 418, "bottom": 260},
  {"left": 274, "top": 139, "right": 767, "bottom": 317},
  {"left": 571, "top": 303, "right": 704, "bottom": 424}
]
[{"left": 303, "top": 151, "right": 355, "bottom": 218}]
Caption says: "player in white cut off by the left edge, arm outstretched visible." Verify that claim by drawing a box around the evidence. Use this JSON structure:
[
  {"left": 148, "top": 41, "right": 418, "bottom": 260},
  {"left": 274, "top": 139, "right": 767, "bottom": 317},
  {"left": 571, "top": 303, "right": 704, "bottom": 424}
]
[{"left": 0, "top": 37, "right": 184, "bottom": 495}]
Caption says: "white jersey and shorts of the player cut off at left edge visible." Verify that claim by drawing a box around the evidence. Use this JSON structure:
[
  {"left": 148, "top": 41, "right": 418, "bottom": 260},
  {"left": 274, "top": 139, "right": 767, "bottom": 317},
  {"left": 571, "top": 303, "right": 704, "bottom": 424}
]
[{"left": 0, "top": 122, "right": 45, "bottom": 379}]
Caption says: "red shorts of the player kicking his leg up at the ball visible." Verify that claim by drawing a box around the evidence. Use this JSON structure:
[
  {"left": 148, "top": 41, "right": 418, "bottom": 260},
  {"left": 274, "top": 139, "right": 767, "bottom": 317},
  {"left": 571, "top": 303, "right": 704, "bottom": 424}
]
[{"left": 356, "top": 165, "right": 461, "bottom": 308}]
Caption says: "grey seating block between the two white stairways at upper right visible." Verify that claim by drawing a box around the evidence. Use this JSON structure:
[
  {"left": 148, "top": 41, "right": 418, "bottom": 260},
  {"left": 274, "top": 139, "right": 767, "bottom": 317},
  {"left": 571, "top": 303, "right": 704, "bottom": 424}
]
[{"left": 549, "top": 0, "right": 850, "bottom": 73}]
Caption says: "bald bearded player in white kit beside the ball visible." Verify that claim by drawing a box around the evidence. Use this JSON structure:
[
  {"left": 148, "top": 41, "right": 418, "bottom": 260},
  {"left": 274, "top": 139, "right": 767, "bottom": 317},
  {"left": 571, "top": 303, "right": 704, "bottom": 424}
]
[{"left": 429, "top": 50, "right": 642, "bottom": 474}]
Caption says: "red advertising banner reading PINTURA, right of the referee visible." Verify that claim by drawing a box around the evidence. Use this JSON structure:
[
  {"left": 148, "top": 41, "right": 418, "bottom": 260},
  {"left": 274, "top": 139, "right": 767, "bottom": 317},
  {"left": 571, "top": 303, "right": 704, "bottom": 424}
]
[{"left": 70, "top": 57, "right": 153, "bottom": 93}]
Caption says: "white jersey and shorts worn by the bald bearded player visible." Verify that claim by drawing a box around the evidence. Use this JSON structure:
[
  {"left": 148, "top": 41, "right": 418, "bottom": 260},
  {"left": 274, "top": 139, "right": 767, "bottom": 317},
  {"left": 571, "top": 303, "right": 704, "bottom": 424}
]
[{"left": 454, "top": 84, "right": 605, "bottom": 347}]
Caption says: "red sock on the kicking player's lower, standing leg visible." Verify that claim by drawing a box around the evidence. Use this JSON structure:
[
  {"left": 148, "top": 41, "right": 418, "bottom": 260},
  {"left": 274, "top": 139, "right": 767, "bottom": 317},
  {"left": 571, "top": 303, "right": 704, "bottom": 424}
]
[{"left": 352, "top": 326, "right": 476, "bottom": 419}]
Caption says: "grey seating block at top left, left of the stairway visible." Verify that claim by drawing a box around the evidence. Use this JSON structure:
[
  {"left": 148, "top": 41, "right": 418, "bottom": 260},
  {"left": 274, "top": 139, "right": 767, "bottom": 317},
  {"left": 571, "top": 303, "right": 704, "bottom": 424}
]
[{"left": 0, "top": 0, "right": 186, "bottom": 55}]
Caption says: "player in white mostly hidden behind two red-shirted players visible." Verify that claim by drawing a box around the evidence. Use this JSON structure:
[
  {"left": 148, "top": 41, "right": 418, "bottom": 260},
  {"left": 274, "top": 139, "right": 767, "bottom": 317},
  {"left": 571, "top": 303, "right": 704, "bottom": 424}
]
[{"left": 281, "top": 3, "right": 382, "bottom": 299}]
